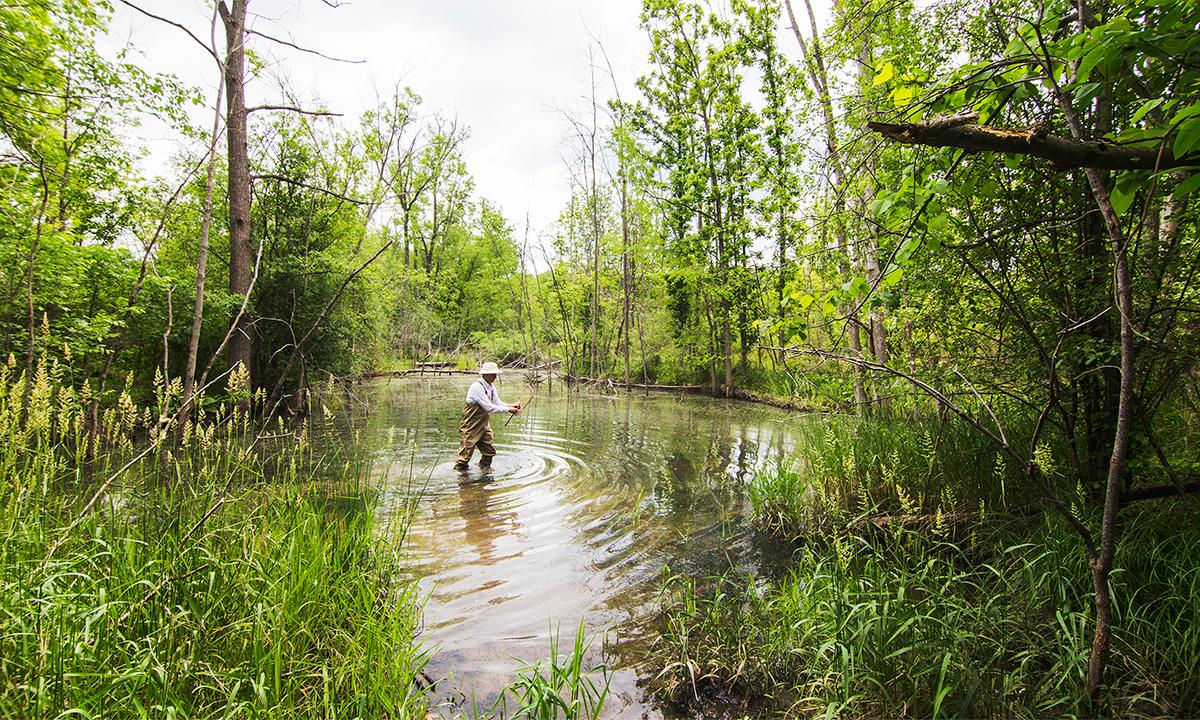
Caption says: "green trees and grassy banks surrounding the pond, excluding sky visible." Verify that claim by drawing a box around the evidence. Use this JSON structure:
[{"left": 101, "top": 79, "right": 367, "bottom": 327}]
[{"left": 0, "top": 0, "right": 1200, "bottom": 718}]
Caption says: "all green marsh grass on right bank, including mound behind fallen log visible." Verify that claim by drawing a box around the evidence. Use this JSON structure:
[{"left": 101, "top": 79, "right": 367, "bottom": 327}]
[{"left": 652, "top": 419, "right": 1200, "bottom": 718}]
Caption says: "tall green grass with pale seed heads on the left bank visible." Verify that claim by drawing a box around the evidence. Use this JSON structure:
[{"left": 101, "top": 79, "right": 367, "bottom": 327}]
[{"left": 0, "top": 366, "right": 426, "bottom": 718}]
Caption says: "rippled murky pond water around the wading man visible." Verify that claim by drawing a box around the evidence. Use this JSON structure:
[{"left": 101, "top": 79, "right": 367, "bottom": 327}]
[{"left": 324, "top": 376, "right": 804, "bottom": 718}]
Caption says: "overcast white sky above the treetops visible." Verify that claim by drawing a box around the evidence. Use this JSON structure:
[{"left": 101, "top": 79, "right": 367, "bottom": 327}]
[{"left": 108, "top": 0, "right": 649, "bottom": 233}]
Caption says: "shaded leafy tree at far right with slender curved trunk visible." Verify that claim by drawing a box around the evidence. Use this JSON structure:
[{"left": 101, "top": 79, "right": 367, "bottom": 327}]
[{"left": 876, "top": 1, "right": 1200, "bottom": 702}]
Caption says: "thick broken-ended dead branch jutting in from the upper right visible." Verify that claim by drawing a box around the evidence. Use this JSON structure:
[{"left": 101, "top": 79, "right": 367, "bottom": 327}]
[{"left": 866, "top": 113, "right": 1188, "bottom": 170}]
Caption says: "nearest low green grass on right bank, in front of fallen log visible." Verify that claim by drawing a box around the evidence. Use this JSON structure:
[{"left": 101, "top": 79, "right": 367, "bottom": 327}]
[{"left": 654, "top": 505, "right": 1200, "bottom": 718}]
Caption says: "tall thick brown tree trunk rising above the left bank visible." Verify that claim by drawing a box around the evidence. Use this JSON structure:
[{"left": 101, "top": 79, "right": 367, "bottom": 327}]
[{"left": 217, "top": 0, "right": 253, "bottom": 389}]
